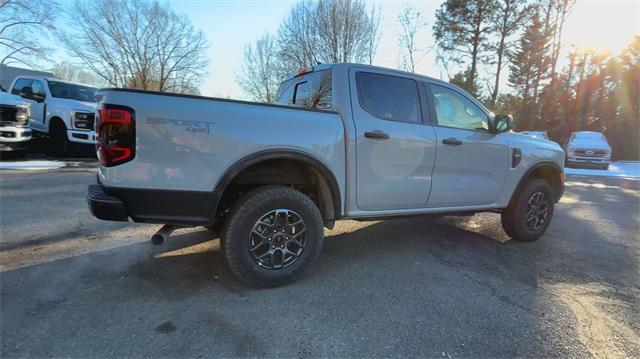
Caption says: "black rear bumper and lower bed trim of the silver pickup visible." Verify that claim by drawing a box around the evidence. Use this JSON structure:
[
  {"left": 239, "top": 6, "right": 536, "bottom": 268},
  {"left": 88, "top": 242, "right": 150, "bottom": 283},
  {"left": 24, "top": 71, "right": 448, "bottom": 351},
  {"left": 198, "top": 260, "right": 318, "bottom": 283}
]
[{"left": 87, "top": 184, "right": 221, "bottom": 226}]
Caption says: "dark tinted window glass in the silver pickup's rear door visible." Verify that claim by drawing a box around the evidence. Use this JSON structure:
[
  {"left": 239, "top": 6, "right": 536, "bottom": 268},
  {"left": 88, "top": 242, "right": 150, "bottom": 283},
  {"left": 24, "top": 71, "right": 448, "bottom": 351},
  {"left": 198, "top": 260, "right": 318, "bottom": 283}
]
[{"left": 356, "top": 72, "right": 422, "bottom": 123}]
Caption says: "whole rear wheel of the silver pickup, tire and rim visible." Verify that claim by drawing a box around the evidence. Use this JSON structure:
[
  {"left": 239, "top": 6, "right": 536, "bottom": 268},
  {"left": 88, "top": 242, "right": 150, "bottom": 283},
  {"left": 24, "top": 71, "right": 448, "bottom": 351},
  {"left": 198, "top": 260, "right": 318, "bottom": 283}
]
[{"left": 222, "top": 186, "right": 324, "bottom": 287}]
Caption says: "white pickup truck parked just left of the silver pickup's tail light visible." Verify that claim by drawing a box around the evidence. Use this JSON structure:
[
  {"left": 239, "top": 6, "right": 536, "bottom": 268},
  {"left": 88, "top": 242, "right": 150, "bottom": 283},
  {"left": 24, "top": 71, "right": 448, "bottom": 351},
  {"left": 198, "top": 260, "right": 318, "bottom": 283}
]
[{"left": 11, "top": 76, "right": 96, "bottom": 154}]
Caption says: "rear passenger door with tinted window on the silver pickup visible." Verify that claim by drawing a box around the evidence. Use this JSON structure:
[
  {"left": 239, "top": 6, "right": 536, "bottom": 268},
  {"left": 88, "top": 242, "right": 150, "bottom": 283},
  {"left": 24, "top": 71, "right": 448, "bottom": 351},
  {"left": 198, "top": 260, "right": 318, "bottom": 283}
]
[{"left": 349, "top": 68, "right": 436, "bottom": 210}]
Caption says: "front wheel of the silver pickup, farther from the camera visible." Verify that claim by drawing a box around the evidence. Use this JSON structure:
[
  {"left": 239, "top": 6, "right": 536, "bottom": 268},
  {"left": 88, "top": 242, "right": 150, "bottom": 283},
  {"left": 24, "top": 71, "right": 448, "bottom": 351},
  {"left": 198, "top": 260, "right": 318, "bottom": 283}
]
[{"left": 502, "top": 179, "right": 554, "bottom": 242}]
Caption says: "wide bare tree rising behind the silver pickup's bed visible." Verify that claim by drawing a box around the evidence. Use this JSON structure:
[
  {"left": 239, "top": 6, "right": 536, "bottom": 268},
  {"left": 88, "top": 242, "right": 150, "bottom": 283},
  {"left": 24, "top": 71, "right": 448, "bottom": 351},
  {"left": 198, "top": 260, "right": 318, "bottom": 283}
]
[{"left": 60, "top": 0, "right": 208, "bottom": 93}]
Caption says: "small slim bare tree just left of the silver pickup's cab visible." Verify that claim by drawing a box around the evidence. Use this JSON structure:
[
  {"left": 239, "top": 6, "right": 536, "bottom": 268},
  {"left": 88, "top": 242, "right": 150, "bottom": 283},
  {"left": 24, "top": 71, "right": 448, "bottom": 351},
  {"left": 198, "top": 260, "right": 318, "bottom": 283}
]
[{"left": 236, "top": 34, "right": 285, "bottom": 103}]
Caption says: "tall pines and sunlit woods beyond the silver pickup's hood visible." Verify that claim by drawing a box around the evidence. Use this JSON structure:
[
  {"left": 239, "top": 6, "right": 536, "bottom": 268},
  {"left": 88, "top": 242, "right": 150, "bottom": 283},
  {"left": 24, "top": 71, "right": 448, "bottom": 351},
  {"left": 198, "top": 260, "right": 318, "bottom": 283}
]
[{"left": 433, "top": 0, "right": 640, "bottom": 159}]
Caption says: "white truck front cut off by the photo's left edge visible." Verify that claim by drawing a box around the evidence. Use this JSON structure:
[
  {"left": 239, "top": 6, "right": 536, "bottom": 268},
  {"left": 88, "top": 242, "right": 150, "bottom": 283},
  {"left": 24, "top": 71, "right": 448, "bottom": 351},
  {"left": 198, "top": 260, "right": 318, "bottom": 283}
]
[{"left": 0, "top": 91, "right": 31, "bottom": 156}]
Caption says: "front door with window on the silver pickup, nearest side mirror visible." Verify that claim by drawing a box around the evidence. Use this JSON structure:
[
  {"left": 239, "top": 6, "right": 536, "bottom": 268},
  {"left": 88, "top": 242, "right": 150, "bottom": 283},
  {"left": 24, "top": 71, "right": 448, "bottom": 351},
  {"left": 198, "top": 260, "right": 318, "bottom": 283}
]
[{"left": 427, "top": 85, "right": 510, "bottom": 208}]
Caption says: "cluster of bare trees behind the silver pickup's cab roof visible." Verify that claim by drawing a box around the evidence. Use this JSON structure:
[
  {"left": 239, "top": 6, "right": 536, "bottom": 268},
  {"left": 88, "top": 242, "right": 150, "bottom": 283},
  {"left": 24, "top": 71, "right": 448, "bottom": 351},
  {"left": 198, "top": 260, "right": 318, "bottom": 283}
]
[{"left": 236, "top": 0, "right": 381, "bottom": 103}]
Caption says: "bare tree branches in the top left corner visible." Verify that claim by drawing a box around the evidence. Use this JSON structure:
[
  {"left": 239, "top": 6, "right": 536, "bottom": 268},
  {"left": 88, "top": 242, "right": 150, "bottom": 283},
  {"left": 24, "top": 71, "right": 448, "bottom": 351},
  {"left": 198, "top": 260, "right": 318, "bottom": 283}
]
[{"left": 0, "top": 0, "right": 58, "bottom": 67}]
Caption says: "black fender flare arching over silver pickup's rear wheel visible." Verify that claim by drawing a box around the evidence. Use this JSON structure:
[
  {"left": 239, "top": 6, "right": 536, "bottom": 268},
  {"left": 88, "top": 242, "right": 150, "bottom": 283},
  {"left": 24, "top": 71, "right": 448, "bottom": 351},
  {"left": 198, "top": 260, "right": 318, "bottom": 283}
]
[{"left": 214, "top": 149, "right": 342, "bottom": 219}]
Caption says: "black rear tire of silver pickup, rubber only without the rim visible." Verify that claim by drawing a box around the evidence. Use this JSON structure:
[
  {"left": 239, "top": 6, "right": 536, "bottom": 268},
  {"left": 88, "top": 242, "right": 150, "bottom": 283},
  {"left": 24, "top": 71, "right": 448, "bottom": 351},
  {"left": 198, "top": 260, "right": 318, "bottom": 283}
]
[{"left": 221, "top": 186, "right": 324, "bottom": 288}]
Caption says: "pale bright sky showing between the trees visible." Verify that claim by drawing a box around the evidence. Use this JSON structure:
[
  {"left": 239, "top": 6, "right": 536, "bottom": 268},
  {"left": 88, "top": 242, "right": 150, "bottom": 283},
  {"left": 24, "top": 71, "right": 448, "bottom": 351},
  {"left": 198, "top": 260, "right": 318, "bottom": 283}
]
[{"left": 42, "top": 0, "right": 640, "bottom": 98}]
